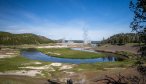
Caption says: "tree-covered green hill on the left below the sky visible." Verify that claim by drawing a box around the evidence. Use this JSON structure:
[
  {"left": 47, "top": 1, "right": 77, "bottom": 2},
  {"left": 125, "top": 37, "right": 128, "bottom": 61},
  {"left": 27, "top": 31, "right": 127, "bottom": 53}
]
[{"left": 0, "top": 32, "right": 54, "bottom": 45}]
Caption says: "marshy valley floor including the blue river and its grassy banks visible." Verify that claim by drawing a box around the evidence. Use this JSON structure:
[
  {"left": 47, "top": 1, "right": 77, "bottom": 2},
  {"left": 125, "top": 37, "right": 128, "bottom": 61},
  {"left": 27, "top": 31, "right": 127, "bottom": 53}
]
[{"left": 0, "top": 45, "right": 141, "bottom": 84}]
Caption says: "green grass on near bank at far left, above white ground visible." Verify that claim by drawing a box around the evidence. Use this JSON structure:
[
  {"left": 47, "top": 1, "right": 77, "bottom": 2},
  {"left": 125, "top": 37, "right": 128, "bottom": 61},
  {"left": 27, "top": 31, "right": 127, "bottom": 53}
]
[{"left": 0, "top": 56, "right": 50, "bottom": 72}]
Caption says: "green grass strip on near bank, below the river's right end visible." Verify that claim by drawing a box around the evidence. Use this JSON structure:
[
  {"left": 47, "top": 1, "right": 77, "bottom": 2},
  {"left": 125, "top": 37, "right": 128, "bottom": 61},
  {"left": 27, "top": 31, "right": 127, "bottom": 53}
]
[{"left": 73, "top": 60, "right": 135, "bottom": 71}]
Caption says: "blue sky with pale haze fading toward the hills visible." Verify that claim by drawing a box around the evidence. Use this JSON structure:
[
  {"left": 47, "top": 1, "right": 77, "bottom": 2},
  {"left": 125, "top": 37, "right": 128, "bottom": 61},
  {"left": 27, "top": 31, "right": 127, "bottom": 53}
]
[{"left": 0, "top": 0, "right": 133, "bottom": 40}]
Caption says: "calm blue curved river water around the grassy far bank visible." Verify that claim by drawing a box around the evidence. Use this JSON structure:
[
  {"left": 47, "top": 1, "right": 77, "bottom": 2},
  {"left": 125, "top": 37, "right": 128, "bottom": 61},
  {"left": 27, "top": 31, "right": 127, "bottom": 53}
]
[{"left": 21, "top": 51, "right": 117, "bottom": 64}]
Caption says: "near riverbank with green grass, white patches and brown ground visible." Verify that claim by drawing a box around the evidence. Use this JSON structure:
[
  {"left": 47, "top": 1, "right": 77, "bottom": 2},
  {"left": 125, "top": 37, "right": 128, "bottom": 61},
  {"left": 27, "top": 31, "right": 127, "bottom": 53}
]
[{"left": 0, "top": 48, "right": 141, "bottom": 84}]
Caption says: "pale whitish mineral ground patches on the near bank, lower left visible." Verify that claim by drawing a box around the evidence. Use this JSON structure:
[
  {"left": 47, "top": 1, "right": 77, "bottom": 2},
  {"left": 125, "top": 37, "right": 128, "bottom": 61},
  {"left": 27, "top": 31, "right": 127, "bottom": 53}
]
[{"left": 0, "top": 62, "right": 74, "bottom": 76}]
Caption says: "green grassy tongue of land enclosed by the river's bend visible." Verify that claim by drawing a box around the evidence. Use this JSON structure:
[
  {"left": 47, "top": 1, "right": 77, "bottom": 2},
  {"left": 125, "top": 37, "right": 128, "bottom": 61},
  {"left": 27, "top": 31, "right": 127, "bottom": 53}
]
[{"left": 37, "top": 48, "right": 105, "bottom": 59}]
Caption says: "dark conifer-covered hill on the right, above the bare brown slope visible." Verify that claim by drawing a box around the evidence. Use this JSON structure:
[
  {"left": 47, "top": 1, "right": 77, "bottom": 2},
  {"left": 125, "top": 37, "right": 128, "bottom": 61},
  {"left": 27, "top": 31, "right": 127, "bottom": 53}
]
[{"left": 101, "top": 33, "right": 139, "bottom": 45}]
